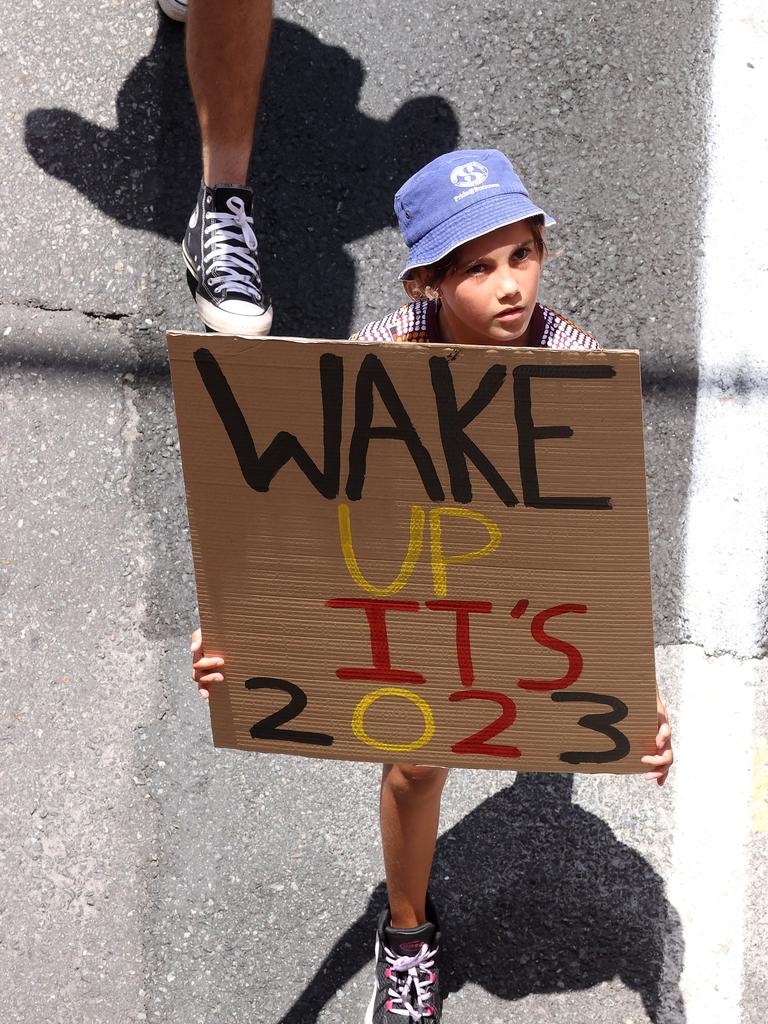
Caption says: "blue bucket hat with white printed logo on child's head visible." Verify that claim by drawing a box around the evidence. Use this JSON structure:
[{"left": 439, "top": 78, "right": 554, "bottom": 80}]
[{"left": 394, "top": 150, "right": 555, "bottom": 281}]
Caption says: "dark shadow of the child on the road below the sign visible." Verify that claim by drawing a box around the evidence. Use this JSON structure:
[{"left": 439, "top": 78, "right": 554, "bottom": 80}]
[{"left": 280, "top": 773, "right": 685, "bottom": 1024}]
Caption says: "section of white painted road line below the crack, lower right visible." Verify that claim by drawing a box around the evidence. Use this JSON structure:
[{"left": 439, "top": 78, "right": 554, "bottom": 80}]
[{"left": 668, "top": 647, "right": 759, "bottom": 1024}]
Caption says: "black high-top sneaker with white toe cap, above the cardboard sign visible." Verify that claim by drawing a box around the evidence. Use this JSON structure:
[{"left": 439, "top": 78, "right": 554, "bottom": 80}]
[{"left": 181, "top": 183, "right": 272, "bottom": 338}]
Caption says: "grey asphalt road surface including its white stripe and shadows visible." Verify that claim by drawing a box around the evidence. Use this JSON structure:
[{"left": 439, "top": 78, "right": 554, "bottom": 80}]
[{"left": 0, "top": 0, "right": 768, "bottom": 1024}]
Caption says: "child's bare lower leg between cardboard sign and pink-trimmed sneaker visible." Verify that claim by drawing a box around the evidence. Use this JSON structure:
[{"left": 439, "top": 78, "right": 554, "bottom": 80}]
[{"left": 381, "top": 765, "right": 447, "bottom": 928}]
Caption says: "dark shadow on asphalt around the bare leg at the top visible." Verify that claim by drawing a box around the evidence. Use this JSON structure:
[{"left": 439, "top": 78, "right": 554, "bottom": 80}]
[{"left": 25, "top": 18, "right": 459, "bottom": 337}]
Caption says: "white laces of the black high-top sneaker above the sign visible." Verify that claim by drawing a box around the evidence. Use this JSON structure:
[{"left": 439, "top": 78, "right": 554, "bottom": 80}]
[{"left": 203, "top": 196, "right": 263, "bottom": 302}]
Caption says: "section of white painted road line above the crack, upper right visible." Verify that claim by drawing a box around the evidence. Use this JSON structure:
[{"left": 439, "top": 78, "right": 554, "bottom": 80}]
[{"left": 685, "top": 0, "right": 768, "bottom": 657}]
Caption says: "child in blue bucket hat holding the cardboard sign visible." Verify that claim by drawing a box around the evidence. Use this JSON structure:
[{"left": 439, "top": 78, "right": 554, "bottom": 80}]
[{"left": 191, "top": 150, "right": 672, "bottom": 1024}]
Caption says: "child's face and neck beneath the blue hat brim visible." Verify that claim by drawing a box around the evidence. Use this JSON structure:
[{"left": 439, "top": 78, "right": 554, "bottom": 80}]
[{"left": 437, "top": 221, "right": 542, "bottom": 345}]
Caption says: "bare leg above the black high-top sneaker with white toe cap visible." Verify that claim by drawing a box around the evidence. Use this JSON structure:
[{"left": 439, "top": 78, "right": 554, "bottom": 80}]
[{"left": 186, "top": 0, "right": 272, "bottom": 186}]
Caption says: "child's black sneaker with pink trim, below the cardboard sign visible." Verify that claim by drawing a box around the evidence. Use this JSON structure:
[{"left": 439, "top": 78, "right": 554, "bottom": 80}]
[{"left": 365, "top": 903, "right": 442, "bottom": 1024}]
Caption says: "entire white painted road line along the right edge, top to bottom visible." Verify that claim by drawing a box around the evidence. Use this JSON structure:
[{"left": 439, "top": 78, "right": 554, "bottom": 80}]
[{"left": 669, "top": 0, "right": 768, "bottom": 1024}]
